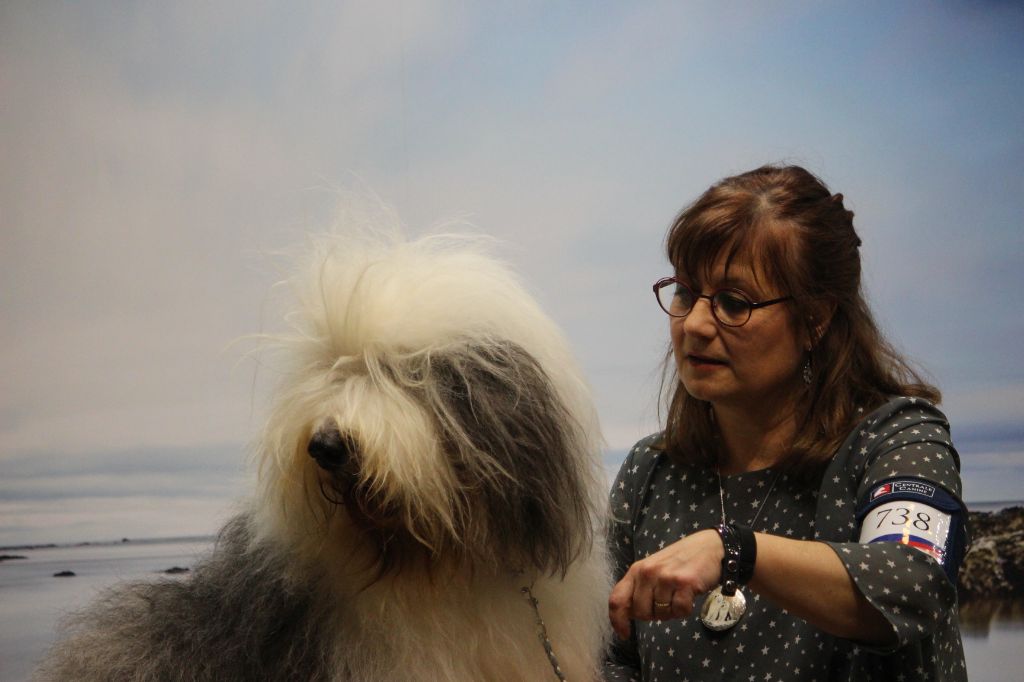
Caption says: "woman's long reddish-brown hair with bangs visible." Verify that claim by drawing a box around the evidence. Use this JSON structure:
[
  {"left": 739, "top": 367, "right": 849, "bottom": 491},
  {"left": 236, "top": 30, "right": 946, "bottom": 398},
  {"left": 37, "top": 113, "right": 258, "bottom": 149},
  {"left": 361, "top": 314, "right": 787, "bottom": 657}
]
[{"left": 665, "top": 166, "right": 940, "bottom": 476}]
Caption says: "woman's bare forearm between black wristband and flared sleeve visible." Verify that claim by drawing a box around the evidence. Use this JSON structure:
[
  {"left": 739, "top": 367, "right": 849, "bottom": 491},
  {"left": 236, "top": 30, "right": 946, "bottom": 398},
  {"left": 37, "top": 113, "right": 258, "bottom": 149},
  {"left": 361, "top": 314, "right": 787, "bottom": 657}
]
[{"left": 750, "top": 532, "right": 896, "bottom": 644}]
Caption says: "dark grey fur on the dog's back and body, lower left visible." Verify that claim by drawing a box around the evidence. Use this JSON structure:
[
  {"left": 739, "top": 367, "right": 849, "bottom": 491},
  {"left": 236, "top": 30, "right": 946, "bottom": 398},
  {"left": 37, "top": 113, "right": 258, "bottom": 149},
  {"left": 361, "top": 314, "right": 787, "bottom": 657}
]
[{"left": 37, "top": 516, "right": 333, "bottom": 682}]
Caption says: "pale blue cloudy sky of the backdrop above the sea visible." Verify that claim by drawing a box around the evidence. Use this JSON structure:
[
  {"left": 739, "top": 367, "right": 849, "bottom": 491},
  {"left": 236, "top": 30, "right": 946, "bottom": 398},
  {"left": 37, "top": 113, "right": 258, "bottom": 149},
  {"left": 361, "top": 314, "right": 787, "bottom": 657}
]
[{"left": 0, "top": 0, "right": 1024, "bottom": 545}]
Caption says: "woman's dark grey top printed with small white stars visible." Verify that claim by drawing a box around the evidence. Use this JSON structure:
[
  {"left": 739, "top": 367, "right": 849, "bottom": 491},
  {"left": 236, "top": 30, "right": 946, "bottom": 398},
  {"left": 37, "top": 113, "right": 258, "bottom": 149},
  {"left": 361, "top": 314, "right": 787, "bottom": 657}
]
[{"left": 604, "top": 397, "right": 967, "bottom": 682}]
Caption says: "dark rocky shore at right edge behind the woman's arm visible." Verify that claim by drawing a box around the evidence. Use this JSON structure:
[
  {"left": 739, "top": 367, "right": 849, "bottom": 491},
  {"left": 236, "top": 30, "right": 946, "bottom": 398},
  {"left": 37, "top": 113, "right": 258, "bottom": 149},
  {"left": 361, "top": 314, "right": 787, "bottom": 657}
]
[{"left": 958, "top": 507, "right": 1024, "bottom": 604}]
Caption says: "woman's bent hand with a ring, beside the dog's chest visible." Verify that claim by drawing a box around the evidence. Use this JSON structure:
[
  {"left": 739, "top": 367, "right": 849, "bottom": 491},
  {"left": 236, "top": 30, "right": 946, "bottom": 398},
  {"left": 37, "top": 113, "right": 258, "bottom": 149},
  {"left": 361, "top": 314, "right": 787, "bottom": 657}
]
[{"left": 608, "top": 529, "right": 725, "bottom": 639}]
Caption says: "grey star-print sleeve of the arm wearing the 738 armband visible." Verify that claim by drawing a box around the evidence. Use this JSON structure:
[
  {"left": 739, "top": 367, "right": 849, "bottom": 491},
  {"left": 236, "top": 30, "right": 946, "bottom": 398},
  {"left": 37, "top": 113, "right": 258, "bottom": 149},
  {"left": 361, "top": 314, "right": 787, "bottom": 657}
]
[{"left": 827, "top": 398, "right": 966, "bottom": 653}]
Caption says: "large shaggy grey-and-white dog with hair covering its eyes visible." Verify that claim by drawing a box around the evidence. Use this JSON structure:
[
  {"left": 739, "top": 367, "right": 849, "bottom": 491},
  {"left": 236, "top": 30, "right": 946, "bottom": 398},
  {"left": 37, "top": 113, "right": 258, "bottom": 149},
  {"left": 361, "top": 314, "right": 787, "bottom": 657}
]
[{"left": 37, "top": 230, "right": 609, "bottom": 682}]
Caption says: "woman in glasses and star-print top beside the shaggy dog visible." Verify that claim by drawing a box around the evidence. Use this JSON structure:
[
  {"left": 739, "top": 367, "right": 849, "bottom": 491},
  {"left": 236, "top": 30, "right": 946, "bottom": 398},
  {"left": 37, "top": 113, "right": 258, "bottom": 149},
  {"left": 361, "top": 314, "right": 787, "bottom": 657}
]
[{"left": 605, "top": 166, "right": 967, "bottom": 682}]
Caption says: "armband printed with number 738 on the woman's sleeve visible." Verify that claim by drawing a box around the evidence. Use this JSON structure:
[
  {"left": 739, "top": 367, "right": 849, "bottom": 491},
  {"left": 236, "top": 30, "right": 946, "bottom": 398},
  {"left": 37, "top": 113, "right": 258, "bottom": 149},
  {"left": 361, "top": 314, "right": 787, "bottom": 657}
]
[{"left": 856, "top": 478, "right": 967, "bottom": 585}]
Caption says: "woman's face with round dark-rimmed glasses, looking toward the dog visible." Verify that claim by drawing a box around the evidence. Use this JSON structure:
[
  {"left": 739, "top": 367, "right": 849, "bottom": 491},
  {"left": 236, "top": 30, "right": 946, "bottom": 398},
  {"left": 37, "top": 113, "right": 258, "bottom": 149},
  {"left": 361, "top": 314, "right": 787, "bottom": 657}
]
[{"left": 671, "top": 250, "right": 804, "bottom": 412}]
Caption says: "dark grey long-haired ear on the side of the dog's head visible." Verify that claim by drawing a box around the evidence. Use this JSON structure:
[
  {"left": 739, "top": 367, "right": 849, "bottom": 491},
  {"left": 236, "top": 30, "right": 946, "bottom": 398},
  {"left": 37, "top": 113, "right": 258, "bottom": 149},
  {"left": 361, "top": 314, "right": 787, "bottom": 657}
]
[{"left": 426, "top": 343, "right": 592, "bottom": 573}]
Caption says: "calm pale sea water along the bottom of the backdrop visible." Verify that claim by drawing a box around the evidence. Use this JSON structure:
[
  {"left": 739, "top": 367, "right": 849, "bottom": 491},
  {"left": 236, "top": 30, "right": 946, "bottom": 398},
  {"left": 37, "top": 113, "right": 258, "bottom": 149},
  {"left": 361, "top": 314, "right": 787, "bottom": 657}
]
[{"left": 0, "top": 539, "right": 1024, "bottom": 682}]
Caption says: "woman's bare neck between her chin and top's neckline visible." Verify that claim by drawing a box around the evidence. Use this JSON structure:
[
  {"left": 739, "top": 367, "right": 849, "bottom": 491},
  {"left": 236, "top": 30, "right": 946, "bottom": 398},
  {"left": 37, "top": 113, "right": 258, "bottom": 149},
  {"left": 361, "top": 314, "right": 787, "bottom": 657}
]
[{"left": 714, "top": 399, "right": 797, "bottom": 476}]
